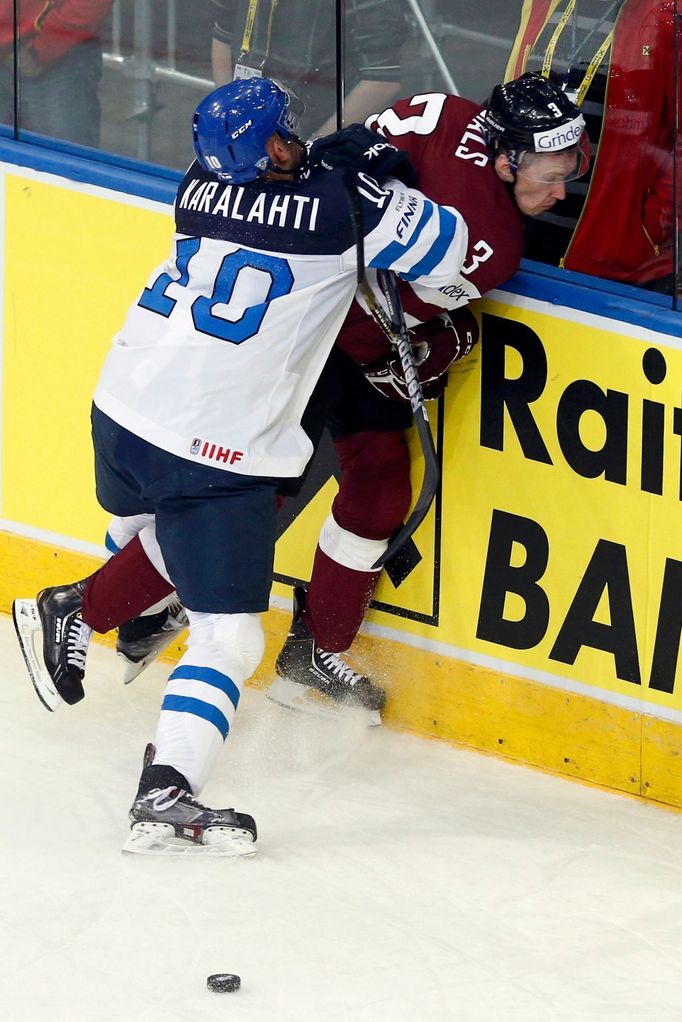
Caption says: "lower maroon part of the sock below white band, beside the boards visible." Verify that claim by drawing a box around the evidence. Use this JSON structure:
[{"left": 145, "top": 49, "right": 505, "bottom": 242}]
[{"left": 304, "top": 547, "right": 381, "bottom": 653}]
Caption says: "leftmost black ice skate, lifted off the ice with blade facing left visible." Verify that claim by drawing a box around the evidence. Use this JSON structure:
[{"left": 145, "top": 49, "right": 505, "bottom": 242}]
[{"left": 12, "top": 579, "right": 92, "bottom": 710}]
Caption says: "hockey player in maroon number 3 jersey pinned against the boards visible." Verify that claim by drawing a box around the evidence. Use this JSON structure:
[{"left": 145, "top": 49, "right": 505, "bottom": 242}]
[{"left": 18, "top": 76, "right": 587, "bottom": 735}]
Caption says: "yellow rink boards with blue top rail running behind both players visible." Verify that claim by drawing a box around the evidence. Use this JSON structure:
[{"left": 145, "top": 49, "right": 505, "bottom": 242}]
[{"left": 0, "top": 151, "right": 682, "bottom": 805}]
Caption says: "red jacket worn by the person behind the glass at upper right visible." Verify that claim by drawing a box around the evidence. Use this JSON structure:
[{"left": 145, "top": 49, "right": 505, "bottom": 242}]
[{"left": 507, "top": 0, "right": 676, "bottom": 283}]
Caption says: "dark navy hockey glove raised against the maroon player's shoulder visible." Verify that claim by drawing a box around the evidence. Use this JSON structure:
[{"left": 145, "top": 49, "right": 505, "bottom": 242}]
[{"left": 306, "top": 124, "right": 416, "bottom": 186}]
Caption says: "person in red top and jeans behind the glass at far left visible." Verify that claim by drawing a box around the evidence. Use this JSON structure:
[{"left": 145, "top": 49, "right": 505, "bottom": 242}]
[{"left": 0, "top": 0, "right": 113, "bottom": 147}]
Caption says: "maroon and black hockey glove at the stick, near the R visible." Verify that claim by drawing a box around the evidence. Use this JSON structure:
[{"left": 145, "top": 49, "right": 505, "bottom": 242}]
[{"left": 360, "top": 309, "right": 479, "bottom": 401}]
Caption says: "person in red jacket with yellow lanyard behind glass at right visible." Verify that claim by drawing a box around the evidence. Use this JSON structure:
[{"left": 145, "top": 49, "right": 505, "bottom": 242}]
[{"left": 507, "top": 0, "right": 676, "bottom": 292}]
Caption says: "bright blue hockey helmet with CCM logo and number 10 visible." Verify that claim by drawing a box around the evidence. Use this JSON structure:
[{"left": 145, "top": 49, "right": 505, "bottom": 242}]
[{"left": 192, "top": 78, "right": 303, "bottom": 184}]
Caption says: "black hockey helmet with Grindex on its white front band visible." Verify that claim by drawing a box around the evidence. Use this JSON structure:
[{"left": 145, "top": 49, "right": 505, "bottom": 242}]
[{"left": 484, "top": 72, "right": 590, "bottom": 181}]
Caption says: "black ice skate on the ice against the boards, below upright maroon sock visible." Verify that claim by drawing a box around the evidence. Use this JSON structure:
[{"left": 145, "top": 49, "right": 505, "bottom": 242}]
[{"left": 266, "top": 587, "right": 385, "bottom": 726}]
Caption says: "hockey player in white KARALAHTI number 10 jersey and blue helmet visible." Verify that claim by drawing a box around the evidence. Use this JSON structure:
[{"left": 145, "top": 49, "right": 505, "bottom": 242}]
[{"left": 14, "top": 79, "right": 467, "bottom": 854}]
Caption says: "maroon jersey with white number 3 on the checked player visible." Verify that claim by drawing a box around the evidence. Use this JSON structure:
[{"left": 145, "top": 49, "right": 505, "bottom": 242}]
[{"left": 336, "top": 92, "right": 522, "bottom": 362}]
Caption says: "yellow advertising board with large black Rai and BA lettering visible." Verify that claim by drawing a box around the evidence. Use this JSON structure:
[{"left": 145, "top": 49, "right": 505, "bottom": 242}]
[{"left": 440, "top": 299, "right": 682, "bottom": 711}]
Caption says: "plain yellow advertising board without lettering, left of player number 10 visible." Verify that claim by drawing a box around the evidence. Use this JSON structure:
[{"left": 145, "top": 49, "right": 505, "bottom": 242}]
[{"left": 1, "top": 168, "right": 173, "bottom": 550}]
